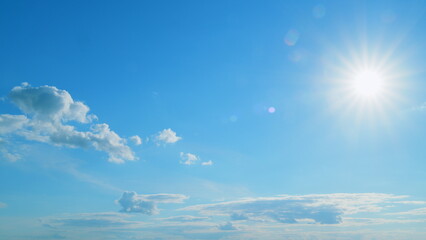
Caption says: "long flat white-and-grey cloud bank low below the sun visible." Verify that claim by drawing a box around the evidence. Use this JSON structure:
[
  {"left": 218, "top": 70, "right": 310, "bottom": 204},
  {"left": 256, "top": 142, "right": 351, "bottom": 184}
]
[{"left": 183, "top": 193, "right": 405, "bottom": 224}]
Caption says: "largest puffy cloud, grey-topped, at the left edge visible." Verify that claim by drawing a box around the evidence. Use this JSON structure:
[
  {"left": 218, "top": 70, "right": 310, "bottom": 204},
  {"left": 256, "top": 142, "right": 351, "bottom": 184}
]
[{"left": 0, "top": 84, "right": 136, "bottom": 163}]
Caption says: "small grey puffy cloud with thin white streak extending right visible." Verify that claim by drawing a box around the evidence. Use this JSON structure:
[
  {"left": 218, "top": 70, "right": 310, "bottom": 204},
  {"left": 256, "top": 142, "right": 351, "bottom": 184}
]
[{"left": 117, "top": 191, "right": 188, "bottom": 215}]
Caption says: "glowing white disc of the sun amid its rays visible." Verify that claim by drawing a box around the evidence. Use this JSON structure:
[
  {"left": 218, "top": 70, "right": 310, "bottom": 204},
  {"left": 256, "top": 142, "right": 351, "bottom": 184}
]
[{"left": 351, "top": 69, "right": 385, "bottom": 99}]
